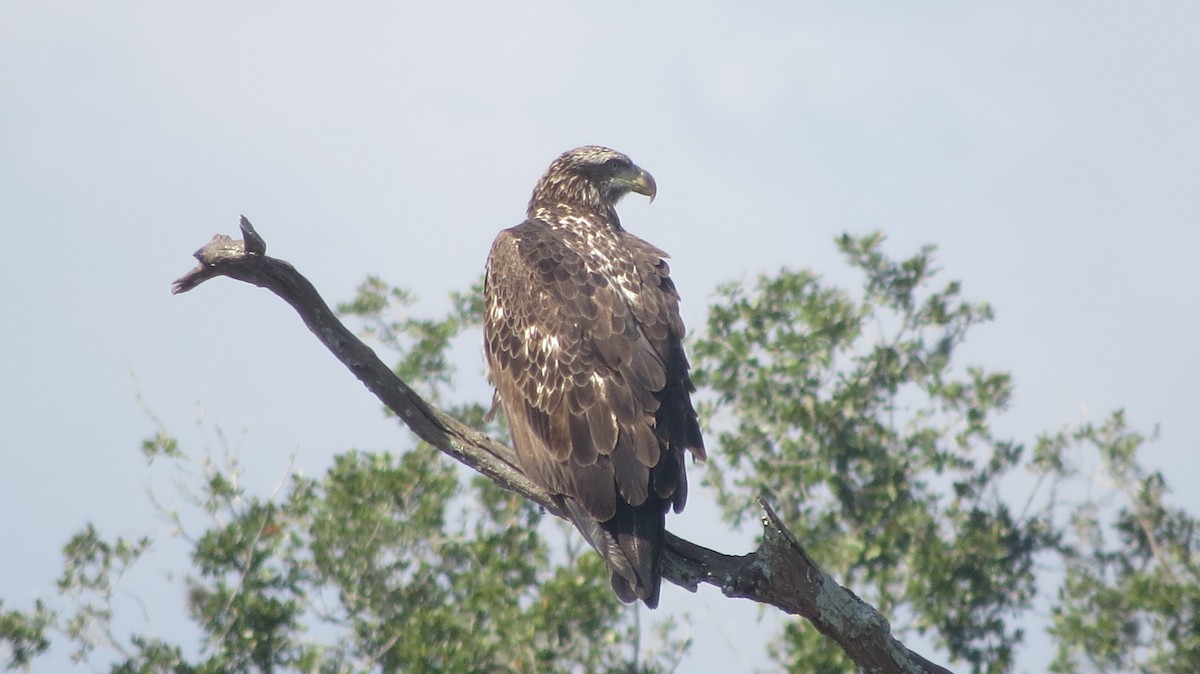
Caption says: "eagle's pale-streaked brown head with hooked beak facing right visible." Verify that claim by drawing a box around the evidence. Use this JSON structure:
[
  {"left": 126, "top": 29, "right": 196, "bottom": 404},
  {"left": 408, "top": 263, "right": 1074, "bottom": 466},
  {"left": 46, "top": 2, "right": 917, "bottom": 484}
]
[{"left": 529, "top": 145, "right": 658, "bottom": 223}]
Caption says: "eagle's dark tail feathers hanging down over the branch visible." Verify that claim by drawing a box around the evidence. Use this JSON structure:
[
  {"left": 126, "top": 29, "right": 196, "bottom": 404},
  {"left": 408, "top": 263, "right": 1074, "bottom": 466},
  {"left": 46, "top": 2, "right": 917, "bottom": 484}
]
[{"left": 564, "top": 497, "right": 667, "bottom": 608}]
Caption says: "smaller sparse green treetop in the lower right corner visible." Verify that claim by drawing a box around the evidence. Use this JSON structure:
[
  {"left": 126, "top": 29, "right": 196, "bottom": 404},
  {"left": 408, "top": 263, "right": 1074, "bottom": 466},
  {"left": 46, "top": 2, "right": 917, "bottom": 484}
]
[{"left": 1039, "top": 411, "right": 1200, "bottom": 674}]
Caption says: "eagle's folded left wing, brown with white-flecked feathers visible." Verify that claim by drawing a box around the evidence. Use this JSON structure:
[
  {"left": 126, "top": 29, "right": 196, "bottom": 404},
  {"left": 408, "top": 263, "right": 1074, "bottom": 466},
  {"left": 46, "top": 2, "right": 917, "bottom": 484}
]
[{"left": 485, "top": 222, "right": 667, "bottom": 510}]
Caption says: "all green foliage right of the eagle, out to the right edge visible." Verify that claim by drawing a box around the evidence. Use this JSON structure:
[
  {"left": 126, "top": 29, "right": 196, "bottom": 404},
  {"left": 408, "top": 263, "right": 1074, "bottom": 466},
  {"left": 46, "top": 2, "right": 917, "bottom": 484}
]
[{"left": 694, "top": 234, "right": 1200, "bottom": 673}]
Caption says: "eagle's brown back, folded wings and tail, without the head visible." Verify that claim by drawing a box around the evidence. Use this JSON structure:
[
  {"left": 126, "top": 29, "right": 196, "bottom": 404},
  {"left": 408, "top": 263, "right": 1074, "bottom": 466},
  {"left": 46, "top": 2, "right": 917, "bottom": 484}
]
[{"left": 485, "top": 222, "right": 698, "bottom": 606}]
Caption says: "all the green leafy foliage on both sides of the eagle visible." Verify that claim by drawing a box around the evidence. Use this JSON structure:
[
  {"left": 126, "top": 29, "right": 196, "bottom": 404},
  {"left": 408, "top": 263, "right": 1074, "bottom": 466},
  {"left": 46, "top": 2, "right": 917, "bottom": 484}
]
[{"left": 0, "top": 235, "right": 1200, "bottom": 673}]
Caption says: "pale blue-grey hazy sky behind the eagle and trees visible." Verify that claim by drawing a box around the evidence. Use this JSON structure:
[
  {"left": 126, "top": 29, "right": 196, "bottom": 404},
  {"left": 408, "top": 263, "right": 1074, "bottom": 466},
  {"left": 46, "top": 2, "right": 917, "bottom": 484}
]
[{"left": 0, "top": 1, "right": 1200, "bottom": 672}]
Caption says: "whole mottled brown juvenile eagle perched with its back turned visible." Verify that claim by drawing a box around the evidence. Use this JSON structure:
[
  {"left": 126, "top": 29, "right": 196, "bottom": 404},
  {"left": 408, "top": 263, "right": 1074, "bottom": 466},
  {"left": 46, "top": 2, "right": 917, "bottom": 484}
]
[{"left": 484, "top": 146, "right": 704, "bottom": 608}]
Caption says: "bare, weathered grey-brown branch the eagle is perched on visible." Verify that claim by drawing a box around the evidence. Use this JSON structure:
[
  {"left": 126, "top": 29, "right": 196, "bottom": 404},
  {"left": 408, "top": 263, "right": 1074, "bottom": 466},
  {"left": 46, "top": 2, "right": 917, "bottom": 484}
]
[{"left": 172, "top": 217, "right": 949, "bottom": 674}]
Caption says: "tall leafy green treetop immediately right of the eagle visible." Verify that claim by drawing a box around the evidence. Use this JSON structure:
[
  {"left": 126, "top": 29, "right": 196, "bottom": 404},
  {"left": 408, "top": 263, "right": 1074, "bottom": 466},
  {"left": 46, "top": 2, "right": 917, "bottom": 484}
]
[{"left": 695, "top": 235, "right": 1056, "bottom": 672}]
